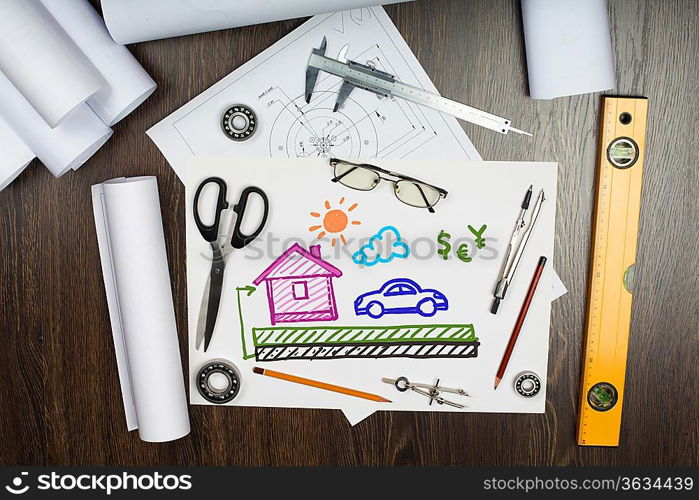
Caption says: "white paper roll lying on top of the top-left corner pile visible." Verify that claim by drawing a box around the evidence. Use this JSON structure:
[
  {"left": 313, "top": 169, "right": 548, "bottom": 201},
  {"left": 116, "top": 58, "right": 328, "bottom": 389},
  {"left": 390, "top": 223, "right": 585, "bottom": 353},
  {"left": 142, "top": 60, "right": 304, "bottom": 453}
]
[{"left": 0, "top": 0, "right": 105, "bottom": 127}]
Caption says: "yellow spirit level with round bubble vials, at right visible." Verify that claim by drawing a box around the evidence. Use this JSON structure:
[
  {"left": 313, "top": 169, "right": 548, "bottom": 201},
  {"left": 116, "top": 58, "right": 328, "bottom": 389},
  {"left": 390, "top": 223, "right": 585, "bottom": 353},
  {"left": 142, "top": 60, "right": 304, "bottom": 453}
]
[{"left": 578, "top": 97, "right": 648, "bottom": 446}]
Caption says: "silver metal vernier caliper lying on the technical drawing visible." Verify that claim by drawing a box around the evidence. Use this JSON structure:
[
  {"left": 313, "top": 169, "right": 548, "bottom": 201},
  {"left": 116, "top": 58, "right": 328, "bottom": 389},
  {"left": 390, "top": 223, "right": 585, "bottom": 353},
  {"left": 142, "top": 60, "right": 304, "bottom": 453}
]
[{"left": 306, "top": 37, "right": 531, "bottom": 136}]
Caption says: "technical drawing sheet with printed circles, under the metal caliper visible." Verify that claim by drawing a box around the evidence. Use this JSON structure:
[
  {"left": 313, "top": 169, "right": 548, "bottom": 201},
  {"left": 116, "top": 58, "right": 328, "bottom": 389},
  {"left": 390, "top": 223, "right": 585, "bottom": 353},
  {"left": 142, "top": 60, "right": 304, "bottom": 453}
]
[{"left": 148, "top": 7, "right": 481, "bottom": 180}]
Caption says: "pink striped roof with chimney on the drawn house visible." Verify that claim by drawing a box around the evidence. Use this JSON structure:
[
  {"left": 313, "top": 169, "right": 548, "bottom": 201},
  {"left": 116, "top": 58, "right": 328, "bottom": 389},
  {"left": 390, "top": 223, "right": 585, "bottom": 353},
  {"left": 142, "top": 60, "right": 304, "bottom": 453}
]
[{"left": 253, "top": 243, "right": 342, "bottom": 285}]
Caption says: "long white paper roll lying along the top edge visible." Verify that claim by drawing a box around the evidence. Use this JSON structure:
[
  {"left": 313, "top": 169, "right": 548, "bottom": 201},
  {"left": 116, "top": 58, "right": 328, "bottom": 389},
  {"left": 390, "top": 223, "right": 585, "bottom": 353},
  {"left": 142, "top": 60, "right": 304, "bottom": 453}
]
[{"left": 102, "top": 0, "right": 409, "bottom": 44}]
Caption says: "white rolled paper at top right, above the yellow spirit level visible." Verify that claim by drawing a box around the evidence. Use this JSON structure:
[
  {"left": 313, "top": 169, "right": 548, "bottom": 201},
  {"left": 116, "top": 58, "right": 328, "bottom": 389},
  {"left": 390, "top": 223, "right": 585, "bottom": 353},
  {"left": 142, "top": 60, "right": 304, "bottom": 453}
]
[{"left": 522, "top": 0, "right": 615, "bottom": 99}]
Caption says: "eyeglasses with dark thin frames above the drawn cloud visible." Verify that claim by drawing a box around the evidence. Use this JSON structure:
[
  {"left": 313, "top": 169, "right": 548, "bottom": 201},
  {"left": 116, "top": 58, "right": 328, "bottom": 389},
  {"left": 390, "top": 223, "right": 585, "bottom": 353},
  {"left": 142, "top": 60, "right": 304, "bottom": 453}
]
[{"left": 330, "top": 158, "right": 447, "bottom": 213}]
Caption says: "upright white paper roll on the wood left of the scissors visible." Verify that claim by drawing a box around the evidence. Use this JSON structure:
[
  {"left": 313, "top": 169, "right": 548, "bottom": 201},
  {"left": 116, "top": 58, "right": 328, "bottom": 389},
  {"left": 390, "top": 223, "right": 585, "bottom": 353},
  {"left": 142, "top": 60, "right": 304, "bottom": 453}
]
[{"left": 92, "top": 177, "right": 189, "bottom": 442}]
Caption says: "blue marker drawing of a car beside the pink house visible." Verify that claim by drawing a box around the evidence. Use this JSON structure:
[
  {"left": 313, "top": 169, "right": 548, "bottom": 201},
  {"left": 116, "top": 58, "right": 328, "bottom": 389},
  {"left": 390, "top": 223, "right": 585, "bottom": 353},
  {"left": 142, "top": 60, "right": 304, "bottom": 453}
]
[{"left": 354, "top": 278, "right": 449, "bottom": 319}]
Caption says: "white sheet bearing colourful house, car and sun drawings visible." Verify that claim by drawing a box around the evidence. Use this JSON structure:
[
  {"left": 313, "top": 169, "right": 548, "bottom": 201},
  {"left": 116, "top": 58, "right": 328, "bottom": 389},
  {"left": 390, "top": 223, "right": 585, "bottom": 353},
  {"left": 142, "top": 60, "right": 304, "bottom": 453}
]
[{"left": 185, "top": 158, "right": 556, "bottom": 419}]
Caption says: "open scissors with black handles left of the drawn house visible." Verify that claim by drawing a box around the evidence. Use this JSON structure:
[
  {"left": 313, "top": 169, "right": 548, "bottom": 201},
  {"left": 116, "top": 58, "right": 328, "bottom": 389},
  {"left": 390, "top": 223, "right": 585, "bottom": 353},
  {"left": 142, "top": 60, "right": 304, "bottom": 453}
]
[{"left": 194, "top": 177, "right": 269, "bottom": 352}]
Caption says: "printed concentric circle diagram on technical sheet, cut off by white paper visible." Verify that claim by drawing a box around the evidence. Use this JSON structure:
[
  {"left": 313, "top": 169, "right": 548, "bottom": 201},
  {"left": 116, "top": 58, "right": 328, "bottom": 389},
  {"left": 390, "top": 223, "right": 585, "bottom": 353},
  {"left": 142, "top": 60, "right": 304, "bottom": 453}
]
[{"left": 269, "top": 91, "right": 378, "bottom": 158}]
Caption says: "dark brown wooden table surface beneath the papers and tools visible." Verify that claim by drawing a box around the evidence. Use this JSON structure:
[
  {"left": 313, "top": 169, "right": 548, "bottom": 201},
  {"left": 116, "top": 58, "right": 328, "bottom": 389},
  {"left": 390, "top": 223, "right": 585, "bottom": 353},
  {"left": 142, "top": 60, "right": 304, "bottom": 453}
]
[{"left": 0, "top": 0, "right": 699, "bottom": 466}]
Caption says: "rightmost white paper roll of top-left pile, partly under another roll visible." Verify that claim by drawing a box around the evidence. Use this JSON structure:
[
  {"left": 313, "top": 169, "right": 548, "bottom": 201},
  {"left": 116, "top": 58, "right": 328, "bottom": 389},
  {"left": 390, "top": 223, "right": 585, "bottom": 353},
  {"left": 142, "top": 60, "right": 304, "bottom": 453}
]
[{"left": 41, "top": 0, "right": 156, "bottom": 126}]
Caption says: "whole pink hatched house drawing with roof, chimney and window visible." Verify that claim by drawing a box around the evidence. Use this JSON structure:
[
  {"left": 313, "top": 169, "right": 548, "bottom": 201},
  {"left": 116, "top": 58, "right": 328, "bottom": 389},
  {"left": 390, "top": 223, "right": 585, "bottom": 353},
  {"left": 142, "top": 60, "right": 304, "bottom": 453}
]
[{"left": 253, "top": 243, "right": 342, "bottom": 325}]
